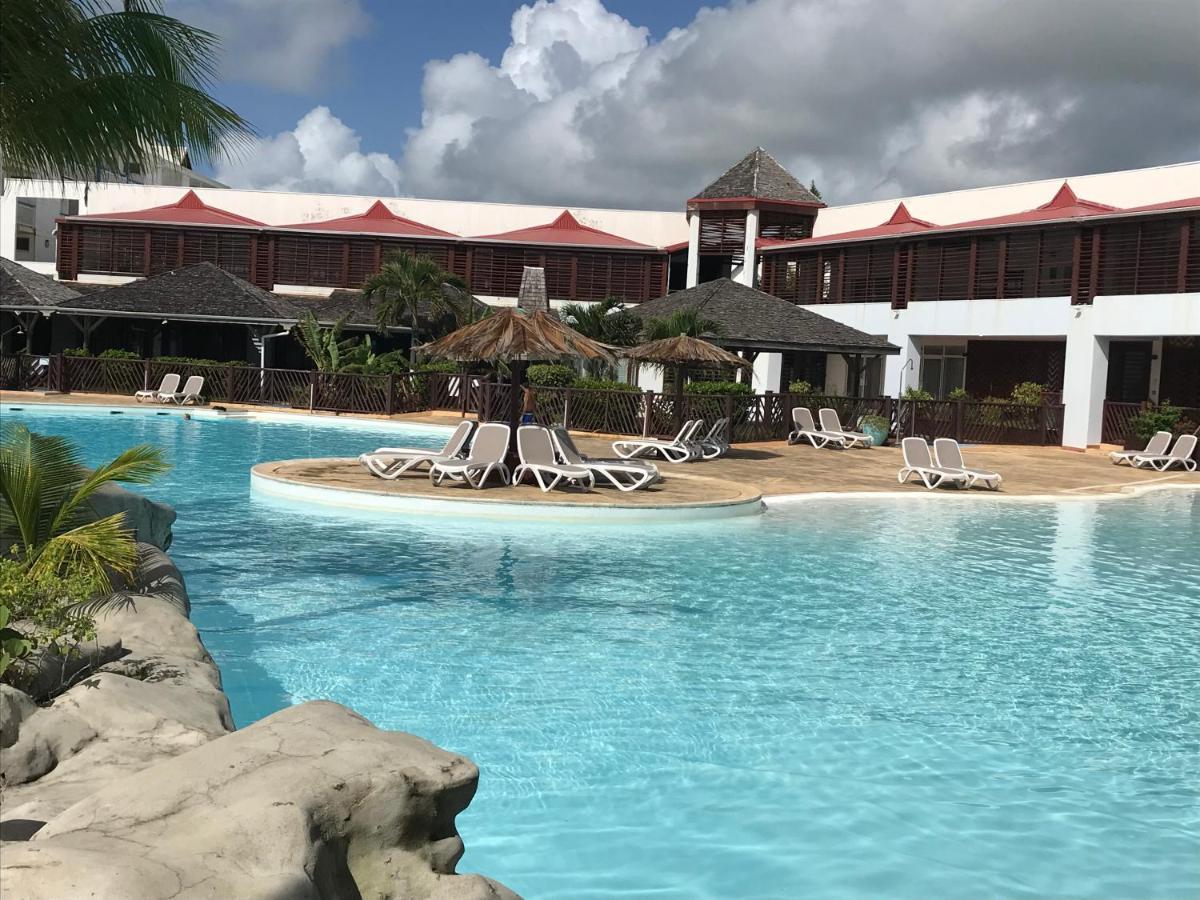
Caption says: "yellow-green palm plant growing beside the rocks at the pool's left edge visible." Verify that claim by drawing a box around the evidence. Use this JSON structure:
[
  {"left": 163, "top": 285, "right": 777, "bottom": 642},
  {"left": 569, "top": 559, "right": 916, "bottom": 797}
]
[{"left": 0, "top": 425, "right": 170, "bottom": 593}]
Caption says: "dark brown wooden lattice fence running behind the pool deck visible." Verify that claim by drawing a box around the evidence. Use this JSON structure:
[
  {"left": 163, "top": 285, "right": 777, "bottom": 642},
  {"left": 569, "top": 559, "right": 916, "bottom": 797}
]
[{"left": 0, "top": 355, "right": 1065, "bottom": 444}]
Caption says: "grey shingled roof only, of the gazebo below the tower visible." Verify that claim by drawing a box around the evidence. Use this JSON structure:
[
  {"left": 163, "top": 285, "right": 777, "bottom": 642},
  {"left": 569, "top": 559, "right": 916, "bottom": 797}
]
[{"left": 630, "top": 278, "right": 900, "bottom": 355}]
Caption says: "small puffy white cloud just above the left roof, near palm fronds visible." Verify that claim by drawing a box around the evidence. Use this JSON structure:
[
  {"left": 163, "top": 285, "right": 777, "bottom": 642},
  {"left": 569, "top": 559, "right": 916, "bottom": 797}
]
[{"left": 216, "top": 107, "right": 401, "bottom": 196}]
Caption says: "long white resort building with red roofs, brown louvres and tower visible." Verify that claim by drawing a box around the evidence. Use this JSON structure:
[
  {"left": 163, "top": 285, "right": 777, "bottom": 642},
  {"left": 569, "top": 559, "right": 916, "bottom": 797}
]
[{"left": 0, "top": 148, "right": 1200, "bottom": 446}]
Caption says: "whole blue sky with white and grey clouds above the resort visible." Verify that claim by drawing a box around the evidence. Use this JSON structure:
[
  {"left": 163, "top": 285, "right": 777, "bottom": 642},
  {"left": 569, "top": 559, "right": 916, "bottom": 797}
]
[{"left": 168, "top": 0, "right": 1200, "bottom": 209}]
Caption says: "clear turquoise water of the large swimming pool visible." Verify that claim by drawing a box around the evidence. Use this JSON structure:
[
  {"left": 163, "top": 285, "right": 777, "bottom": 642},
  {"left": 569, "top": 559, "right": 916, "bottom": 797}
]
[{"left": 5, "top": 408, "right": 1200, "bottom": 898}]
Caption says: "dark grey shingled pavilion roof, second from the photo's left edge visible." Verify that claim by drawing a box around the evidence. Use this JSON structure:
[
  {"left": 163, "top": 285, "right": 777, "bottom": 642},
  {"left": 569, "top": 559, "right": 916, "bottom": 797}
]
[{"left": 58, "top": 263, "right": 300, "bottom": 324}]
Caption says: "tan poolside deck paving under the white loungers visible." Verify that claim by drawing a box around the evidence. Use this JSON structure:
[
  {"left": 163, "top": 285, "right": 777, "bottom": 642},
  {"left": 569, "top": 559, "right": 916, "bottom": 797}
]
[{"left": 7, "top": 391, "right": 1200, "bottom": 508}]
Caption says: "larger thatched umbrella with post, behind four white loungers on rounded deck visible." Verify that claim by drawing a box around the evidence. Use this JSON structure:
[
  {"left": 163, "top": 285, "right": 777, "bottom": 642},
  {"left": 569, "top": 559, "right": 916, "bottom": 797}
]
[{"left": 418, "top": 307, "right": 614, "bottom": 465}]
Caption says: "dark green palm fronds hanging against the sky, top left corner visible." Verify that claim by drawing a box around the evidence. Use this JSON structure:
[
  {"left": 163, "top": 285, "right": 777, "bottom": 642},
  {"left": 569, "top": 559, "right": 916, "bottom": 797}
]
[{"left": 0, "top": 0, "right": 253, "bottom": 179}]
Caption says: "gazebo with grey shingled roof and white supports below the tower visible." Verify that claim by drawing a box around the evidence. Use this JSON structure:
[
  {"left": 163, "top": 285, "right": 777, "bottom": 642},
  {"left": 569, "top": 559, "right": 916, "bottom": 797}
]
[{"left": 630, "top": 278, "right": 900, "bottom": 395}]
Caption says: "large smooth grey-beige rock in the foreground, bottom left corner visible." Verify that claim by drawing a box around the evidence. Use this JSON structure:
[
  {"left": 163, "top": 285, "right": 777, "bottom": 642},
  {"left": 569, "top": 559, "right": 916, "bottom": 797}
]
[{"left": 4, "top": 702, "right": 516, "bottom": 900}]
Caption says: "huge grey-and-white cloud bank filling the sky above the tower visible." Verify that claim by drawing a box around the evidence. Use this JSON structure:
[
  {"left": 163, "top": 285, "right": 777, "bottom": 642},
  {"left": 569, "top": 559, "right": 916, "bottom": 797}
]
[{"left": 402, "top": 0, "right": 1200, "bottom": 209}]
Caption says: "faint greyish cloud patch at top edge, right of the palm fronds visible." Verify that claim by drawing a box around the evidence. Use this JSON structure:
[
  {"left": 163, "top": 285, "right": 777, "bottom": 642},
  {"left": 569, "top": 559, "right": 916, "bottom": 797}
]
[{"left": 167, "top": 0, "right": 368, "bottom": 91}]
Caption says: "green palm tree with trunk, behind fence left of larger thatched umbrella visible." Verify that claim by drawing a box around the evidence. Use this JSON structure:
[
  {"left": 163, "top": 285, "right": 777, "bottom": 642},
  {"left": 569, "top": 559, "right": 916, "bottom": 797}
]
[{"left": 362, "top": 251, "right": 466, "bottom": 366}]
